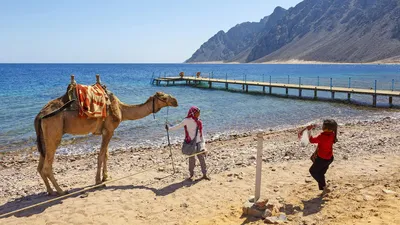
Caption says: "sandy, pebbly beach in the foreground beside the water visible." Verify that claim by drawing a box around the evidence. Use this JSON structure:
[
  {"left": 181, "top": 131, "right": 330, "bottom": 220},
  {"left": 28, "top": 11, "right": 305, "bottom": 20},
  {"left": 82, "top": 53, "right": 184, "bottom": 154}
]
[{"left": 0, "top": 117, "right": 400, "bottom": 225}]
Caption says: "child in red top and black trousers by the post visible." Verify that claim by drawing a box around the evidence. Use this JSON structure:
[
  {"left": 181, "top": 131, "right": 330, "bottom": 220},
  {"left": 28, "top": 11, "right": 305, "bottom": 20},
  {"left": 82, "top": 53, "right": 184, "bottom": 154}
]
[{"left": 302, "top": 119, "right": 338, "bottom": 193}]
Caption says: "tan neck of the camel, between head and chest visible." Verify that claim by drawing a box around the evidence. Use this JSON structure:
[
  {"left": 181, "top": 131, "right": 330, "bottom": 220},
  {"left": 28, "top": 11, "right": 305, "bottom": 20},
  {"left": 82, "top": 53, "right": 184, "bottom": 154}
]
[{"left": 120, "top": 98, "right": 153, "bottom": 120}]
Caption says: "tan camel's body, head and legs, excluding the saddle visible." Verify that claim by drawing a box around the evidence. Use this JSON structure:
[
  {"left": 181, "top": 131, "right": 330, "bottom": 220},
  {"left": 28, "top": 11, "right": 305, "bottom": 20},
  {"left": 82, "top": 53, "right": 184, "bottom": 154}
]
[{"left": 34, "top": 81, "right": 178, "bottom": 195}]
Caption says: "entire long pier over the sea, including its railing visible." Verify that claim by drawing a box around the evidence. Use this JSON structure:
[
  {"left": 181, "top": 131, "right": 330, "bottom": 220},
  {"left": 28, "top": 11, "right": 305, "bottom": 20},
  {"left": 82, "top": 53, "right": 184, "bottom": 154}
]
[{"left": 152, "top": 73, "right": 400, "bottom": 107}]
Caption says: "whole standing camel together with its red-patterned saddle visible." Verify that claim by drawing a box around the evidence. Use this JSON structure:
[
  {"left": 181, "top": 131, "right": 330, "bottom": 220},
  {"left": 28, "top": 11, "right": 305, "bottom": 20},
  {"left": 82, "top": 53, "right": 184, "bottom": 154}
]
[{"left": 34, "top": 75, "right": 178, "bottom": 195}]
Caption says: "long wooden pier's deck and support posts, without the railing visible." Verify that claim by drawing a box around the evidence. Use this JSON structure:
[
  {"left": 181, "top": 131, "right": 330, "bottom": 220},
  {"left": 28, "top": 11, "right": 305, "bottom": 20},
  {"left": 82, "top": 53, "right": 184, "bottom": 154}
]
[{"left": 152, "top": 76, "right": 400, "bottom": 107}]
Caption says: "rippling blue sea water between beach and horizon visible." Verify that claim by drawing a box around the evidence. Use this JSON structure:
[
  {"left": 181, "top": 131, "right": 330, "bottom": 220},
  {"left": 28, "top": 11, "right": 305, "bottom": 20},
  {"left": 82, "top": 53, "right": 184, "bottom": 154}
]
[{"left": 0, "top": 64, "right": 400, "bottom": 154}]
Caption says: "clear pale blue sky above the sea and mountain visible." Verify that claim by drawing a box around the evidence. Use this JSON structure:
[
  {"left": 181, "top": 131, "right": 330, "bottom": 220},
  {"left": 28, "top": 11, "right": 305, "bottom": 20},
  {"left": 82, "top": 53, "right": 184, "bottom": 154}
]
[{"left": 0, "top": 0, "right": 301, "bottom": 63}]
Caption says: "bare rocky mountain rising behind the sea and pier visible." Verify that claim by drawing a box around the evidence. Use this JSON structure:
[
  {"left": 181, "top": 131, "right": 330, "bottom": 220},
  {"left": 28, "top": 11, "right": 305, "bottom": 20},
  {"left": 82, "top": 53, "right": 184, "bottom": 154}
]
[{"left": 186, "top": 0, "right": 400, "bottom": 63}]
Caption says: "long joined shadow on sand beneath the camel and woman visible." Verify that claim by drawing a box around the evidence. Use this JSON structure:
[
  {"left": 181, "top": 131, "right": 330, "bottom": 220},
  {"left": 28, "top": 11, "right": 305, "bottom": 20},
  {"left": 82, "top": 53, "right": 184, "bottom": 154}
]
[{"left": 0, "top": 179, "right": 205, "bottom": 219}]
